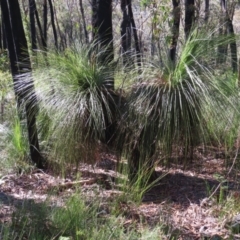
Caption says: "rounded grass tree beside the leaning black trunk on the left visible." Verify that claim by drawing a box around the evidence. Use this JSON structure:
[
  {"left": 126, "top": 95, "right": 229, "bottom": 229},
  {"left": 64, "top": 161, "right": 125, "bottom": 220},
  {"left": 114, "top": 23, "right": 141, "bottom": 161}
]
[{"left": 18, "top": 45, "right": 119, "bottom": 169}]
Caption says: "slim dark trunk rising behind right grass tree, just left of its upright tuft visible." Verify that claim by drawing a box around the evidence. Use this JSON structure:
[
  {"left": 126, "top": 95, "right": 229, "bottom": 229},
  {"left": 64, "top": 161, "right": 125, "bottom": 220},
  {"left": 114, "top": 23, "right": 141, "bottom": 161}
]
[{"left": 169, "top": 0, "right": 181, "bottom": 63}]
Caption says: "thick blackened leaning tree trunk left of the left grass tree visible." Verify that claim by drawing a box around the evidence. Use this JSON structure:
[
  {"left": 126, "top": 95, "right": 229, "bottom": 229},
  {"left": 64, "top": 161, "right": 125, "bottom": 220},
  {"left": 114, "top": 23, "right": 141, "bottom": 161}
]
[{"left": 1, "top": 0, "right": 43, "bottom": 168}]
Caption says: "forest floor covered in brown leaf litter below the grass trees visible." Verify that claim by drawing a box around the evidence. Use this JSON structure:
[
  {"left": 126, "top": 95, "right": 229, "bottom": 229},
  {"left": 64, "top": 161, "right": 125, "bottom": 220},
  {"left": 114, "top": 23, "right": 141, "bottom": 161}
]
[{"left": 0, "top": 148, "right": 240, "bottom": 239}]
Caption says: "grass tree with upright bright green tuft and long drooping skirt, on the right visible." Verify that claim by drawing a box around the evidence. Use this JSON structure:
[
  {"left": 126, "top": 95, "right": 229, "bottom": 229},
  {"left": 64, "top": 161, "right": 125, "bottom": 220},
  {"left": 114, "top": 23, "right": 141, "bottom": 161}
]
[{"left": 125, "top": 30, "right": 238, "bottom": 184}]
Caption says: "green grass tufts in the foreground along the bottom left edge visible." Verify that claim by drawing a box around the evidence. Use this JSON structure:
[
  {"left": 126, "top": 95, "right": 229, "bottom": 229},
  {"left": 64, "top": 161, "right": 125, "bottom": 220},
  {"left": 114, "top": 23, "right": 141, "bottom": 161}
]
[{"left": 0, "top": 194, "right": 167, "bottom": 240}]
